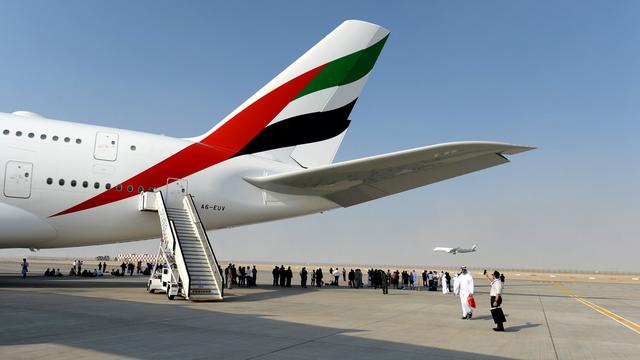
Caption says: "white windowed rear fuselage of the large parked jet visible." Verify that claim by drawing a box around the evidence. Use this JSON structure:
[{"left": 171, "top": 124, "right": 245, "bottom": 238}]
[{"left": 0, "top": 113, "right": 337, "bottom": 248}]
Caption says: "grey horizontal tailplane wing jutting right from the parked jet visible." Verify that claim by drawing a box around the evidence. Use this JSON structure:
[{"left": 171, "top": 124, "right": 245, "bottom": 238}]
[{"left": 245, "top": 142, "right": 534, "bottom": 207}]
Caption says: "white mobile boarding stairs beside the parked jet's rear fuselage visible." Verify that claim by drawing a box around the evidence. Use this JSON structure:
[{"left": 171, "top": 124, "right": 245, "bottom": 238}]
[{"left": 139, "top": 192, "right": 224, "bottom": 301}]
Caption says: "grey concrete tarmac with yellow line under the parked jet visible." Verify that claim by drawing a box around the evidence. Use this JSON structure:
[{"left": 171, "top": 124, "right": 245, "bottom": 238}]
[{"left": 0, "top": 264, "right": 640, "bottom": 360}]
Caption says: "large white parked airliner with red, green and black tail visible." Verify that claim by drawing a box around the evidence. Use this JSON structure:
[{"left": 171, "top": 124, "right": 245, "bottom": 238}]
[{"left": 0, "top": 20, "right": 531, "bottom": 248}]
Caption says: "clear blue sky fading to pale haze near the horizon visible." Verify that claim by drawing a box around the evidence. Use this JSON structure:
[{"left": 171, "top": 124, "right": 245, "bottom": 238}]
[{"left": 0, "top": 0, "right": 640, "bottom": 270}]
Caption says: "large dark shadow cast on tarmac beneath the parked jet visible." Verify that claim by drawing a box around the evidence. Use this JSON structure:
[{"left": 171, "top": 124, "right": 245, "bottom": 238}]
[{"left": 0, "top": 278, "right": 516, "bottom": 360}]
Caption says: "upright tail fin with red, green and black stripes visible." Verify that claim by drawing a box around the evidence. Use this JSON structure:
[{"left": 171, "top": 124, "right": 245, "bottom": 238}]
[{"left": 192, "top": 20, "right": 389, "bottom": 167}]
